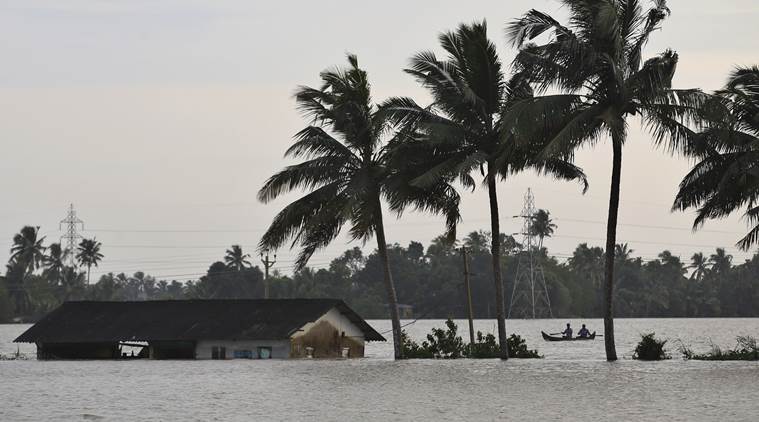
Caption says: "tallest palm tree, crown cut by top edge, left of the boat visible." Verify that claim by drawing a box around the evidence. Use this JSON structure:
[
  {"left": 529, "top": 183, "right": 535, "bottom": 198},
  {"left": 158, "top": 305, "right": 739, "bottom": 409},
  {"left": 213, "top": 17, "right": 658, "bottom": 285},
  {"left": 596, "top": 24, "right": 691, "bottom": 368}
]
[{"left": 507, "top": 0, "right": 706, "bottom": 361}]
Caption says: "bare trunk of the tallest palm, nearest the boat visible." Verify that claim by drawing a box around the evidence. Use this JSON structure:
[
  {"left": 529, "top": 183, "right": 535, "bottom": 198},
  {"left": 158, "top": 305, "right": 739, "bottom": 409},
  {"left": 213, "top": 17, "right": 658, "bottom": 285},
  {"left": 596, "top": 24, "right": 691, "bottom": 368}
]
[{"left": 604, "top": 133, "right": 624, "bottom": 362}]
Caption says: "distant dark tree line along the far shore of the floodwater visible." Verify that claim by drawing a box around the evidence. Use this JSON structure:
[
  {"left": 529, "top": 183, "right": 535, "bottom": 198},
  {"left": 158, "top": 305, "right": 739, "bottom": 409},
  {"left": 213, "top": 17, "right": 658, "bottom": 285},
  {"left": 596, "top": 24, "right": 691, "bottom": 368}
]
[{"left": 0, "top": 224, "right": 759, "bottom": 322}]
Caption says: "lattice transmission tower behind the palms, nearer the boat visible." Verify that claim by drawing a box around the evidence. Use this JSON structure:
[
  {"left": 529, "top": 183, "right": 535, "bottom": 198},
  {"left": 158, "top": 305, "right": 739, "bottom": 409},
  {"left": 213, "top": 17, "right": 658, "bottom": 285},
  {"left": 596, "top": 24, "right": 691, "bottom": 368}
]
[{"left": 508, "top": 188, "right": 553, "bottom": 319}]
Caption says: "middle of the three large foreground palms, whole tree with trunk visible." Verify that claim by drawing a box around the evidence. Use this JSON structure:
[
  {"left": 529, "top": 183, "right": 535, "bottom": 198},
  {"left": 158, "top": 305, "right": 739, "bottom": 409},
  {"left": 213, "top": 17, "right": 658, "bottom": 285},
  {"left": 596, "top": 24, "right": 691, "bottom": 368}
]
[{"left": 384, "top": 22, "right": 587, "bottom": 359}]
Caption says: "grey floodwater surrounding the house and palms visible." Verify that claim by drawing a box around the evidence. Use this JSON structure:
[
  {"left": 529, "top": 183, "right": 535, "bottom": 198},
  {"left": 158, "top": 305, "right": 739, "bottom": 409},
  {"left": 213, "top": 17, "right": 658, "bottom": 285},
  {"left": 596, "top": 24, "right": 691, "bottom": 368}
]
[{"left": 0, "top": 319, "right": 759, "bottom": 421}]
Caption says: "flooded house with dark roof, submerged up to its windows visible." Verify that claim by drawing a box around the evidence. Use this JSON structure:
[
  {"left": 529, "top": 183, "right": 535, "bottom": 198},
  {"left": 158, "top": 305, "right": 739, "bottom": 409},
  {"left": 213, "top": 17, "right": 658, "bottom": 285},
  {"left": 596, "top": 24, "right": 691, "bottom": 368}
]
[{"left": 14, "top": 299, "right": 385, "bottom": 359}]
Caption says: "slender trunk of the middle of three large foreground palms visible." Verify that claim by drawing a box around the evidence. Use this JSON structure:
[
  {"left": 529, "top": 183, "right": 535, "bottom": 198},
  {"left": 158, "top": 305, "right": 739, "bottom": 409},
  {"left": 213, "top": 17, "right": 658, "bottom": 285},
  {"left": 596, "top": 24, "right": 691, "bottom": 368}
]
[{"left": 488, "top": 171, "right": 509, "bottom": 360}]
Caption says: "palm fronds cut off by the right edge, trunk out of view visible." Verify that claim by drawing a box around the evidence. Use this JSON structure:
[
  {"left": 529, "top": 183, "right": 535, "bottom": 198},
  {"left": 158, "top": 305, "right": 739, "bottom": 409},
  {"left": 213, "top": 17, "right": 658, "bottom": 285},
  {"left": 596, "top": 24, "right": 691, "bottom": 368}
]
[{"left": 673, "top": 66, "right": 759, "bottom": 250}]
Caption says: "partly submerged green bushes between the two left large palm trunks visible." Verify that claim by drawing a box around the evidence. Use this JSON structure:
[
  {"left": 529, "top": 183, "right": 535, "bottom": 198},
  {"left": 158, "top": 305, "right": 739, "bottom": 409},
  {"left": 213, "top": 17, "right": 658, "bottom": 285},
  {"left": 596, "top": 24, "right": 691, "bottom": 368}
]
[{"left": 401, "top": 319, "right": 541, "bottom": 359}]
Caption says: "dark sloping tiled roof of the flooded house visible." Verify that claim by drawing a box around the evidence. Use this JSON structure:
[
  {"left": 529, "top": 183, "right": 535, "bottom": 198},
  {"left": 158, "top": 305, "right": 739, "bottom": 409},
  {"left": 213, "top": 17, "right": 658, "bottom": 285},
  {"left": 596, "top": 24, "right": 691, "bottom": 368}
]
[{"left": 14, "top": 299, "right": 385, "bottom": 343}]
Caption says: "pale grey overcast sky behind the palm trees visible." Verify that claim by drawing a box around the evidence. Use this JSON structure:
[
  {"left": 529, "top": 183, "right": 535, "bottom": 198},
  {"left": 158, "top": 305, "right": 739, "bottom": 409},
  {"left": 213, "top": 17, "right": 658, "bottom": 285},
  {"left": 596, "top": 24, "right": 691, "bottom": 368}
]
[{"left": 0, "top": 0, "right": 759, "bottom": 280}]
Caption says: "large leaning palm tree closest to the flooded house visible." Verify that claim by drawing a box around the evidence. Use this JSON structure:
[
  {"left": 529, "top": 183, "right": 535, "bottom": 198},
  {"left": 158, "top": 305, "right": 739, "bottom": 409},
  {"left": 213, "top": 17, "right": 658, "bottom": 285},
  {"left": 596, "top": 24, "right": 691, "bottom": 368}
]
[{"left": 258, "top": 55, "right": 459, "bottom": 359}]
